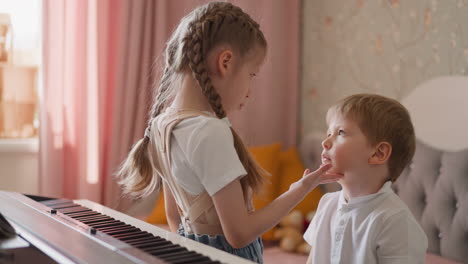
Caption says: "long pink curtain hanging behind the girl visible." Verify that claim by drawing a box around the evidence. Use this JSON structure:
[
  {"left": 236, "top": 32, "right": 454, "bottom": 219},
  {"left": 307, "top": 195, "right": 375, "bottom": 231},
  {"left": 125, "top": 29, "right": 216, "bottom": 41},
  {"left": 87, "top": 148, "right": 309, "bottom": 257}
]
[{"left": 39, "top": 0, "right": 300, "bottom": 207}]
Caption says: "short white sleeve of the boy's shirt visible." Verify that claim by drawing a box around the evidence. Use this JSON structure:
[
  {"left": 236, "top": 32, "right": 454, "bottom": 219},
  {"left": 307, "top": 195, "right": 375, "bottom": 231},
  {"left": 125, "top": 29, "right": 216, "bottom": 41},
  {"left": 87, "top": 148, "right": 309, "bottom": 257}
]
[{"left": 376, "top": 211, "right": 427, "bottom": 264}]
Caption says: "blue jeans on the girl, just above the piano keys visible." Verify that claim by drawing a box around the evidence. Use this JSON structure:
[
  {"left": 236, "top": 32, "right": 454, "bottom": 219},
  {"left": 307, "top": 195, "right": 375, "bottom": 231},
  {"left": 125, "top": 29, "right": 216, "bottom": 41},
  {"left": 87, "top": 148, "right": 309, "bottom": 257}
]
[{"left": 178, "top": 224, "right": 263, "bottom": 264}]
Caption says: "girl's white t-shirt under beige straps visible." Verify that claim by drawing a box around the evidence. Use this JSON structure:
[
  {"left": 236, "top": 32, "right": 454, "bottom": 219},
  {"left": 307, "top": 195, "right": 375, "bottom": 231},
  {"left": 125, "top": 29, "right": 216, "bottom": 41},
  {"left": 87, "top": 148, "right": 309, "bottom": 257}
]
[{"left": 171, "top": 116, "right": 247, "bottom": 196}]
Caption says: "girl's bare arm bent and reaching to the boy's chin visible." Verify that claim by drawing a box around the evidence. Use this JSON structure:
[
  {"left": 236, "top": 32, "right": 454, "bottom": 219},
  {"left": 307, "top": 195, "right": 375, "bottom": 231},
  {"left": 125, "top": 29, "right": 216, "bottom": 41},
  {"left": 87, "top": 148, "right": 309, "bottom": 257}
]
[{"left": 213, "top": 164, "right": 342, "bottom": 248}]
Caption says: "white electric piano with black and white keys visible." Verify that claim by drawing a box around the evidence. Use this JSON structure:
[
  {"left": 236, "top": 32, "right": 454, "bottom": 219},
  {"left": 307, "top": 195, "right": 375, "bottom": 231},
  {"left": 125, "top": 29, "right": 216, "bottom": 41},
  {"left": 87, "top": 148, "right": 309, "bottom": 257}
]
[{"left": 0, "top": 191, "right": 253, "bottom": 264}]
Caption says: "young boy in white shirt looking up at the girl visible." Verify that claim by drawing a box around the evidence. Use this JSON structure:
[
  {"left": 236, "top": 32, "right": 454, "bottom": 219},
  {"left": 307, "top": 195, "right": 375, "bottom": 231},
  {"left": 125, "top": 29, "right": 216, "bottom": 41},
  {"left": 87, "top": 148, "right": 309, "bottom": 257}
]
[{"left": 304, "top": 94, "right": 427, "bottom": 264}]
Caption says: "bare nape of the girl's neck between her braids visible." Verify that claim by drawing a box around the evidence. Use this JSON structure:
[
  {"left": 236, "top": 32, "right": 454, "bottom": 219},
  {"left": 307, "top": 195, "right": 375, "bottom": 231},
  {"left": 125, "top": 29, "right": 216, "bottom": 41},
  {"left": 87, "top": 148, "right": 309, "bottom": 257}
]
[{"left": 171, "top": 74, "right": 213, "bottom": 112}]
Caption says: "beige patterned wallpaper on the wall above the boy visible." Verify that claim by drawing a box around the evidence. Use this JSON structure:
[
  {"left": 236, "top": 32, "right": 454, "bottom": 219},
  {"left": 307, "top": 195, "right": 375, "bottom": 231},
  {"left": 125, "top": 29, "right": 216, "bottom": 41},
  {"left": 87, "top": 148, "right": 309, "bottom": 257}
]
[{"left": 299, "top": 0, "right": 468, "bottom": 138}]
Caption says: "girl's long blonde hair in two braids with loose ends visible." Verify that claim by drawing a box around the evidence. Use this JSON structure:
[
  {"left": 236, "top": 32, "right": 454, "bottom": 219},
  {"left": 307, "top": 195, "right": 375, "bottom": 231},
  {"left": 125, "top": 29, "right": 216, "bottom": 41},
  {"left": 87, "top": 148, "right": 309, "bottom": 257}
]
[{"left": 117, "top": 2, "right": 267, "bottom": 198}]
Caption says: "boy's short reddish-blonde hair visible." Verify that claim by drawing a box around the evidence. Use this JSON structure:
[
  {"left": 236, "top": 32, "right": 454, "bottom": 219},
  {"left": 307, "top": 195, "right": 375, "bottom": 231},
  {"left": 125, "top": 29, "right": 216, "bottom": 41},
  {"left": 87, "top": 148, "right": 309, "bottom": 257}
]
[{"left": 327, "top": 94, "right": 416, "bottom": 182}]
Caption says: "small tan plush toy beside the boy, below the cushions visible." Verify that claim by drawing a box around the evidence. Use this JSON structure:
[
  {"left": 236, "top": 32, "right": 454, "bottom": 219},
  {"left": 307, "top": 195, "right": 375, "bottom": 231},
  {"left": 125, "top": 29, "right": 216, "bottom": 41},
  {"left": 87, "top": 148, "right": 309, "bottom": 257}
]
[{"left": 274, "top": 210, "right": 315, "bottom": 254}]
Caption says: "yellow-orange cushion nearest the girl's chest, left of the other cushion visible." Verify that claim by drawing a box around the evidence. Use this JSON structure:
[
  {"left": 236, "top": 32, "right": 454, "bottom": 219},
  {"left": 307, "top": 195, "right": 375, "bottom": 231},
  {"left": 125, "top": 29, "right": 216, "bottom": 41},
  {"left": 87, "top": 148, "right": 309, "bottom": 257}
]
[{"left": 249, "top": 143, "right": 281, "bottom": 240}]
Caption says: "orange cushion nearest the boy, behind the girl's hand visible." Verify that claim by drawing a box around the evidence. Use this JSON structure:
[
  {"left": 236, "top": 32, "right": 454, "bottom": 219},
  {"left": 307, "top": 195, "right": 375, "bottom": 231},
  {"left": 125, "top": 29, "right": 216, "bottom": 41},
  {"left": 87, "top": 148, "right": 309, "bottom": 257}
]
[{"left": 277, "top": 147, "right": 323, "bottom": 215}]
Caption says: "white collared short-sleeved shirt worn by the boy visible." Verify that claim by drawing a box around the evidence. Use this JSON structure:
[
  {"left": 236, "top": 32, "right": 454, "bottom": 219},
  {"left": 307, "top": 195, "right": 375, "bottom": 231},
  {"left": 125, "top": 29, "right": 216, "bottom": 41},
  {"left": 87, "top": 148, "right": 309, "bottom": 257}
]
[{"left": 304, "top": 182, "right": 428, "bottom": 264}]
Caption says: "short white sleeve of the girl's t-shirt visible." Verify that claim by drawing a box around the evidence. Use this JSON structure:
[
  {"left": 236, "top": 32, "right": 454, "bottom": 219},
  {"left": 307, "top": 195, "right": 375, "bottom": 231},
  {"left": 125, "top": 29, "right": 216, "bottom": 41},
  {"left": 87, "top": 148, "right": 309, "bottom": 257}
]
[{"left": 187, "top": 118, "right": 247, "bottom": 196}]
